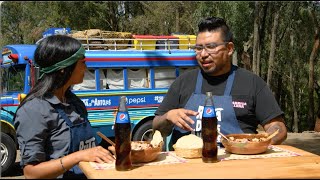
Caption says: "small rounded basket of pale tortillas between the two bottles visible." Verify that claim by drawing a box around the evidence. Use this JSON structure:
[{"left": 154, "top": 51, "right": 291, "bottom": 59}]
[{"left": 172, "top": 134, "right": 203, "bottom": 159}]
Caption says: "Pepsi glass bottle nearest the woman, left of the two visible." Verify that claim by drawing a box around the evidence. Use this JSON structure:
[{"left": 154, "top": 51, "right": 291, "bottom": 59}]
[{"left": 114, "top": 96, "right": 132, "bottom": 171}]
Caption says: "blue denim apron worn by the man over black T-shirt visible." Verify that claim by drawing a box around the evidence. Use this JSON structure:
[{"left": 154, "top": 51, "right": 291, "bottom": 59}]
[{"left": 169, "top": 65, "right": 243, "bottom": 150}]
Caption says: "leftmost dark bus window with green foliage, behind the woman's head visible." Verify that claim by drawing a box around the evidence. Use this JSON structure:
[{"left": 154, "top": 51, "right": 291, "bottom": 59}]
[{"left": 1, "top": 64, "right": 26, "bottom": 93}]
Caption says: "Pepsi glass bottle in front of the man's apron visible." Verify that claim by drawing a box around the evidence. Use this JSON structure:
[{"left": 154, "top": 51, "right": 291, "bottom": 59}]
[{"left": 201, "top": 92, "right": 218, "bottom": 163}]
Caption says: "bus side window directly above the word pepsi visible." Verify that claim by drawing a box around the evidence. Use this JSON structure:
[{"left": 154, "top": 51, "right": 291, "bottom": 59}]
[{"left": 128, "top": 68, "right": 150, "bottom": 89}]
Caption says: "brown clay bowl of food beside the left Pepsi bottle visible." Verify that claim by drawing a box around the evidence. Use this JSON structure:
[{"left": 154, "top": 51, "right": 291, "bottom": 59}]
[{"left": 131, "top": 141, "right": 163, "bottom": 163}]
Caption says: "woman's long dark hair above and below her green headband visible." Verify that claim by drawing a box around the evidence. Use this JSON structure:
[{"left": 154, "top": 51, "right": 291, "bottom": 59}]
[{"left": 18, "top": 35, "right": 81, "bottom": 108}]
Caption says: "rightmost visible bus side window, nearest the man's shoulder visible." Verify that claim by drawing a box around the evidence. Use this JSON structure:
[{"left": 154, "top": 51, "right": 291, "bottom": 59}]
[{"left": 154, "top": 67, "right": 176, "bottom": 88}]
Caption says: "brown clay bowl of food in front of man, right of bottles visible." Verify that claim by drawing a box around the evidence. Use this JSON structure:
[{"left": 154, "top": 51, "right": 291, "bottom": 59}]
[{"left": 221, "top": 134, "right": 271, "bottom": 154}]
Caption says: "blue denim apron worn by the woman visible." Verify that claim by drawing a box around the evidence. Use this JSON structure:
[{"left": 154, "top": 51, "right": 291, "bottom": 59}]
[{"left": 56, "top": 105, "right": 97, "bottom": 179}]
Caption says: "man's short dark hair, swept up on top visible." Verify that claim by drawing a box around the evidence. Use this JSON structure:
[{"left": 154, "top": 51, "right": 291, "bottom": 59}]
[{"left": 198, "top": 17, "right": 233, "bottom": 42}]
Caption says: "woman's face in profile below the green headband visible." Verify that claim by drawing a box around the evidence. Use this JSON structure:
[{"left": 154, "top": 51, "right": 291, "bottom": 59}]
[{"left": 68, "top": 58, "right": 87, "bottom": 85}]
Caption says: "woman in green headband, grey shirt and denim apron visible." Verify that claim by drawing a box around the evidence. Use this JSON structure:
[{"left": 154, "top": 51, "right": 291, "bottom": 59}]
[{"left": 14, "top": 35, "right": 114, "bottom": 178}]
